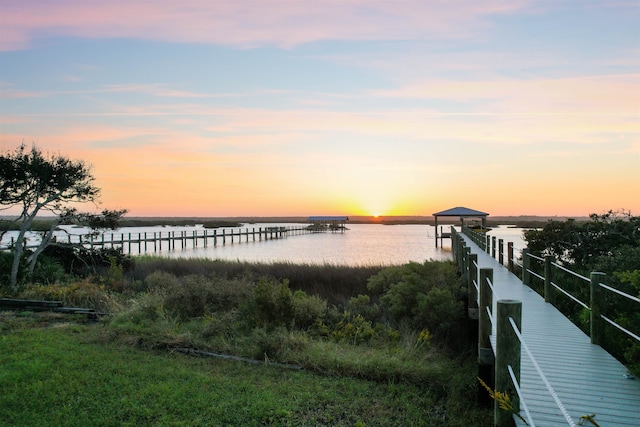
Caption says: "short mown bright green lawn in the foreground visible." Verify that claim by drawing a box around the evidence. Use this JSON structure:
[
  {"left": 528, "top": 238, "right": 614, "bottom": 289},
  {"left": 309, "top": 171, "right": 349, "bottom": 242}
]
[{"left": 0, "top": 314, "right": 490, "bottom": 426}]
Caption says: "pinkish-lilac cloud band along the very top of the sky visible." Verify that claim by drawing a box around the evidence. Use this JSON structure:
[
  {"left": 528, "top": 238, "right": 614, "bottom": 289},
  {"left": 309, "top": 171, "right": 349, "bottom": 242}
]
[{"left": 0, "top": 0, "right": 529, "bottom": 50}]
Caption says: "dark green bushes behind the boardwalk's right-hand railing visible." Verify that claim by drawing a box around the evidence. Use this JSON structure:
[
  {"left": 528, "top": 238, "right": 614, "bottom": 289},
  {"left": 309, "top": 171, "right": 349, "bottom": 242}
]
[{"left": 525, "top": 211, "right": 640, "bottom": 374}]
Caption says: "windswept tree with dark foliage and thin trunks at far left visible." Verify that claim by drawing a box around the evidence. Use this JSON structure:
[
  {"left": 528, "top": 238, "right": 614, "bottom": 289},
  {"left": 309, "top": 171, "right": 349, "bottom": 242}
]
[{"left": 0, "top": 144, "right": 126, "bottom": 290}]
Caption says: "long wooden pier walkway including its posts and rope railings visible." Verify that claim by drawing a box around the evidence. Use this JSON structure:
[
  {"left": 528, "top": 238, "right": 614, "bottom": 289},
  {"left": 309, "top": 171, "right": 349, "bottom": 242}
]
[{"left": 452, "top": 227, "right": 640, "bottom": 427}]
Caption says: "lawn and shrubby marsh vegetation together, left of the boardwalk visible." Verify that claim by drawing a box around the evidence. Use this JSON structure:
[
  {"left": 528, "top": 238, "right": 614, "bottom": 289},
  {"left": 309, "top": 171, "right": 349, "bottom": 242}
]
[{"left": 0, "top": 254, "right": 491, "bottom": 426}]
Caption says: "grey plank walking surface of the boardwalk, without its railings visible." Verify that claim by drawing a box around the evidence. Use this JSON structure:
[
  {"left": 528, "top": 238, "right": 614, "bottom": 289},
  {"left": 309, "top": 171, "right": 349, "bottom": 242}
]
[{"left": 463, "top": 236, "right": 640, "bottom": 427}]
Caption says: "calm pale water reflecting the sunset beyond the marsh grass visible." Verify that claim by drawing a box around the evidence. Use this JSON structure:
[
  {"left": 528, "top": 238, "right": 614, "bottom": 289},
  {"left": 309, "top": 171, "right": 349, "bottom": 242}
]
[{"left": 4, "top": 224, "right": 525, "bottom": 265}]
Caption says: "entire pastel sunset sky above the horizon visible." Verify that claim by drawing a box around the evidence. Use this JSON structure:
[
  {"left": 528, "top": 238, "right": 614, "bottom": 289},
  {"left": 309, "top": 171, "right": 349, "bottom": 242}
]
[{"left": 0, "top": 0, "right": 640, "bottom": 217}]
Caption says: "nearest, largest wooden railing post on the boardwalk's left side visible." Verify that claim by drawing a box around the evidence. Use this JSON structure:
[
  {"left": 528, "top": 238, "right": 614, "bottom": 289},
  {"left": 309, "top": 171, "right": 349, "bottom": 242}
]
[{"left": 493, "top": 300, "right": 522, "bottom": 427}]
